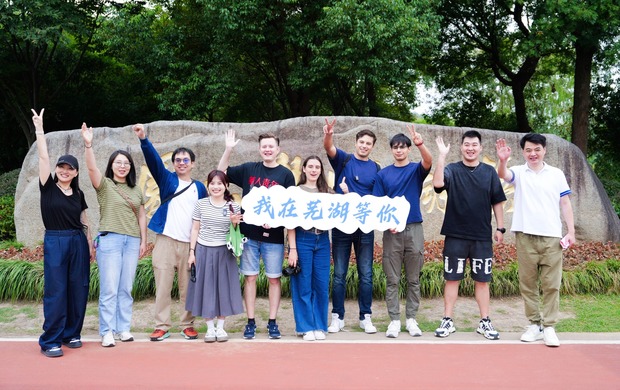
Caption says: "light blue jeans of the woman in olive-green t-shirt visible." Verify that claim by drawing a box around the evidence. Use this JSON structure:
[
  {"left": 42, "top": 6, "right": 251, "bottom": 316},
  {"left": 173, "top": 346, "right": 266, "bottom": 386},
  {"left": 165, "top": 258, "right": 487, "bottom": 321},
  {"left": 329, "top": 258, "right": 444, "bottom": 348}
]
[{"left": 97, "top": 232, "right": 140, "bottom": 336}]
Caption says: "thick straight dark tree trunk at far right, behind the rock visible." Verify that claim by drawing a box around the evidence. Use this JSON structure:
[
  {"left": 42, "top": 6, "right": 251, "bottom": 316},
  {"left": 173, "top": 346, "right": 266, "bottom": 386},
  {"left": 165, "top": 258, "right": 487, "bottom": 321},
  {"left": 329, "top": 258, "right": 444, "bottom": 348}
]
[{"left": 571, "top": 34, "right": 597, "bottom": 156}]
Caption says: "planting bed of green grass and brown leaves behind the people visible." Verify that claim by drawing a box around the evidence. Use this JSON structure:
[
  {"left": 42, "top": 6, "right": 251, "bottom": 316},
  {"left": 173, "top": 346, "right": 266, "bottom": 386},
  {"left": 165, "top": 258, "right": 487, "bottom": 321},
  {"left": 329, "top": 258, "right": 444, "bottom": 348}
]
[{"left": 0, "top": 241, "right": 620, "bottom": 300}]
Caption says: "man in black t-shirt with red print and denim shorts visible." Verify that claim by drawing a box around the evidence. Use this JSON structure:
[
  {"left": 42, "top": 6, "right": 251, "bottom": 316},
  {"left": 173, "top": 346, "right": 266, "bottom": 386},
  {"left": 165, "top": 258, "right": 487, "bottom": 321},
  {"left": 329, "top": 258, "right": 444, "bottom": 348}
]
[{"left": 218, "top": 130, "right": 296, "bottom": 339}]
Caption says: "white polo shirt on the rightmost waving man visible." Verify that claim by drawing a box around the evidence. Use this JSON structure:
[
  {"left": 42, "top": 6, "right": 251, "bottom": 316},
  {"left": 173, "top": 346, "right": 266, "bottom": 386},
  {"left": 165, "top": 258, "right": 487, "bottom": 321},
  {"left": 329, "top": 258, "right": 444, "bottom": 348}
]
[{"left": 509, "top": 162, "right": 571, "bottom": 238}]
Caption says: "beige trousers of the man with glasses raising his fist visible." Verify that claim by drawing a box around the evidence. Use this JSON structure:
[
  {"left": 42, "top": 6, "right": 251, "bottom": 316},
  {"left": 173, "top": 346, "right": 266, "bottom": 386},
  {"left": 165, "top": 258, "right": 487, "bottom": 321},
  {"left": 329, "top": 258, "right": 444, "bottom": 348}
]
[{"left": 152, "top": 234, "right": 194, "bottom": 331}]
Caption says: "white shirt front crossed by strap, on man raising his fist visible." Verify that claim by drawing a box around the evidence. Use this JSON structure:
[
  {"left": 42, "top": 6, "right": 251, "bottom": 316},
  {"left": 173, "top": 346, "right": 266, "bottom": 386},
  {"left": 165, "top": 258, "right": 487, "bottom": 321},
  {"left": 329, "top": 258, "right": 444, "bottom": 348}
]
[{"left": 162, "top": 179, "right": 198, "bottom": 242}]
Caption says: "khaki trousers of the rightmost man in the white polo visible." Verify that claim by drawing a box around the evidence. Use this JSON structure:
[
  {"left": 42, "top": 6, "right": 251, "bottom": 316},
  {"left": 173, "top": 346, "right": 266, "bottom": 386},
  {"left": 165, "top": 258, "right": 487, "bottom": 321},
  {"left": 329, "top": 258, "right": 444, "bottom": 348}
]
[{"left": 516, "top": 232, "right": 562, "bottom": 327}]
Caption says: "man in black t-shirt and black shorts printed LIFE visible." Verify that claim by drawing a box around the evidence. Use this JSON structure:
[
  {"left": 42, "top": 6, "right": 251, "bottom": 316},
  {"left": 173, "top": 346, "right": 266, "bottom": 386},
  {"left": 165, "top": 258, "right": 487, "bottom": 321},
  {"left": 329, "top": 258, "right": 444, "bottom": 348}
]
[{"left": 433, "top": 130, "right": 506, "bottom": 340}]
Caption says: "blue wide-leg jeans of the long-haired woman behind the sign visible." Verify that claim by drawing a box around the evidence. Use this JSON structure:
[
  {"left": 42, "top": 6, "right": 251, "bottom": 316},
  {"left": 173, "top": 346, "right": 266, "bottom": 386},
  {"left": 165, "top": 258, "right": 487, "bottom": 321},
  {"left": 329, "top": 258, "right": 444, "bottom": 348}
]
[{"left": 291, "top": 228, "right": 329, "bottom": 333}]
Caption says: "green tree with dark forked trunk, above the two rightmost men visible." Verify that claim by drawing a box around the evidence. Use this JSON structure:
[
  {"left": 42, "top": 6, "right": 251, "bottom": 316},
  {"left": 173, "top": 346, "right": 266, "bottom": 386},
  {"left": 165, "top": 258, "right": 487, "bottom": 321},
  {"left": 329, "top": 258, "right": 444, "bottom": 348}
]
[{"left": 431, "top": 0, "right": 557, "bottom": 132}]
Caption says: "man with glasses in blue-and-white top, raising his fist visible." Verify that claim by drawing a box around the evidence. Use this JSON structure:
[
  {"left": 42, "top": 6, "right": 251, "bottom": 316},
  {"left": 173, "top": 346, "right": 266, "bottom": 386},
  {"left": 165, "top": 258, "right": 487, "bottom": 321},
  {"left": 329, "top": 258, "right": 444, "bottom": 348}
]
[{"left": 133, "top": 124, "right": 207, "bottom": 341}]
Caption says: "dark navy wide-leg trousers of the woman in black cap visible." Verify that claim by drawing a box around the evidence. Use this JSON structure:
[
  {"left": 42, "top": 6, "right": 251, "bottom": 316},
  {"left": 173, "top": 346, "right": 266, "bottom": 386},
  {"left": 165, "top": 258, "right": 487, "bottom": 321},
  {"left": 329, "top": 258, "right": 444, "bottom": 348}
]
[{"left": 39, "top": 230, "right": 90, "bottom": 350}]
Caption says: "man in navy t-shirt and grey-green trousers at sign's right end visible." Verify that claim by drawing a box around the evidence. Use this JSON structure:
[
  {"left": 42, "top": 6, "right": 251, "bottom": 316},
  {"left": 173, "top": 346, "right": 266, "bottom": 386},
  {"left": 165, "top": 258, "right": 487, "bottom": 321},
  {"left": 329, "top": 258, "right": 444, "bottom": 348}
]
[{"left": 372, "top": 125, "right": 433, "bottom": 338}]
